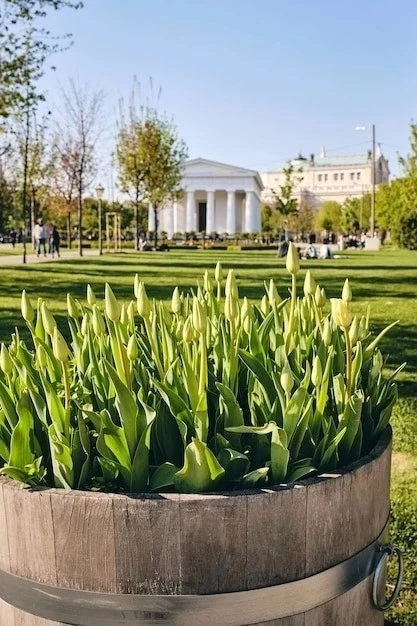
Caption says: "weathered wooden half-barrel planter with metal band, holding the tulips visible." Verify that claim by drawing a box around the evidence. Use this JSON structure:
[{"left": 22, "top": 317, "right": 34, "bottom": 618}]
[{"left": 0, "top": 428, "right": 391, "bottom": 626}]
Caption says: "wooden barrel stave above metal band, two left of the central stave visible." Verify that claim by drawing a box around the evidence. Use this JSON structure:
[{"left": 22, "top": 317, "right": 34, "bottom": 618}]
[{"left": 52, "top": 492, "right": 117, "bottom": 593}]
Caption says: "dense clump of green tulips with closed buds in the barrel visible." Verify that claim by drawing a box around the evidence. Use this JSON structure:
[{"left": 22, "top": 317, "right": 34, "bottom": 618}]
[{"left": 0, "top": 244, "right": 404, "bottom": 493}]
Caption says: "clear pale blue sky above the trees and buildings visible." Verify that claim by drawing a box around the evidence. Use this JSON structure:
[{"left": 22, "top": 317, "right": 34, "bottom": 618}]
[{"left": 40, "top": 0, "right": 417, "bottom": 180}]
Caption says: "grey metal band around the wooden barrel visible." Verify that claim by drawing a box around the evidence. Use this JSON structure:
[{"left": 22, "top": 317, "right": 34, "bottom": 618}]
[{"left": 0, "top": 522, "right": 388, "bottom": 626}]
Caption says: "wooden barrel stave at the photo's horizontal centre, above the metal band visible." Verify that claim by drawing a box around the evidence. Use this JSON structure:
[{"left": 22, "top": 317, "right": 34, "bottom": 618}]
[{"left": 180, "top": 494, "right": 247, "bottom": 594}]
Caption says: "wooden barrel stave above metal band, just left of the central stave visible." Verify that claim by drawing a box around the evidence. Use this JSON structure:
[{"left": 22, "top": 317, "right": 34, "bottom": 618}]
[{"left": 113, "top": 494, "right": 181, "bottom": 595}]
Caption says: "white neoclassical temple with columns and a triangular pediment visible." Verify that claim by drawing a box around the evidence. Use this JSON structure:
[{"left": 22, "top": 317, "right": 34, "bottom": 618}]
[{"left": 149, "top": 159, "right": 264, "bottom": 238}]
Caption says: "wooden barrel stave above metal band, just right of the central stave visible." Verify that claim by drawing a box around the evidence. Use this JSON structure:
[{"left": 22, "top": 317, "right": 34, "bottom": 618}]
[{"left": 246, "top": 487, "right": 307, "bottom": 589}]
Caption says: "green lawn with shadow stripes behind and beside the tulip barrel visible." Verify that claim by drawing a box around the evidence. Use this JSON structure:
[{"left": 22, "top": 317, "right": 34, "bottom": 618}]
[{"left": 0, "top": 250, "right": 417, "bottom": 626}]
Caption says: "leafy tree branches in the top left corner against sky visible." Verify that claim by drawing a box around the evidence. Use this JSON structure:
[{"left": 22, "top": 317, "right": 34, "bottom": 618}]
[{"left": 0, "top": 0, "right": 82, "bottom": 119}]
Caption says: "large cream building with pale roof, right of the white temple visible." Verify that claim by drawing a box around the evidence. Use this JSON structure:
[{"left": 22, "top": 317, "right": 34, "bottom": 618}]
[{"left": 261, "top": 147, "right": 390, "bottom": 206}]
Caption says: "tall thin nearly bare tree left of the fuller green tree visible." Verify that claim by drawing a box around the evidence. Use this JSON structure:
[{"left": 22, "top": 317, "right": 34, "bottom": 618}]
[{"left": 54, "top": 80, "right": 104, "bottom": 256}]
